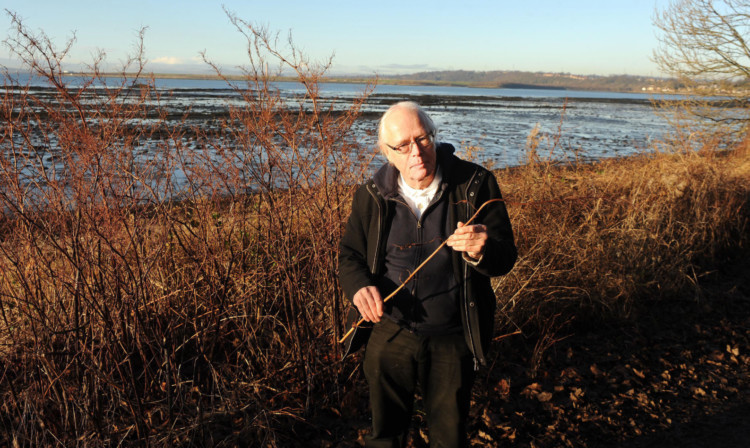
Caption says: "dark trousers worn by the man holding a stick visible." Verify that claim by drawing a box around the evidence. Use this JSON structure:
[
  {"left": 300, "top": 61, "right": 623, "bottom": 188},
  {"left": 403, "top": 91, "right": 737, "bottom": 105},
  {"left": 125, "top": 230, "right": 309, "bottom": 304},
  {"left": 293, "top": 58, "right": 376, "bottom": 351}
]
[{"left": 364, "top": 318, "right": 474, "bottom": 448}]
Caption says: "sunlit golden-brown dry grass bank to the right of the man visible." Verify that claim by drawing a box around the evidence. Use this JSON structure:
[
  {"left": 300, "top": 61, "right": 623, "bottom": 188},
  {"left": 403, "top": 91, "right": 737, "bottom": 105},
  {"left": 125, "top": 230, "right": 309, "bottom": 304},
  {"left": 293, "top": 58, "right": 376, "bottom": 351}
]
[{"left": 496, "top": 142, "right": 750, "bottom": 372}]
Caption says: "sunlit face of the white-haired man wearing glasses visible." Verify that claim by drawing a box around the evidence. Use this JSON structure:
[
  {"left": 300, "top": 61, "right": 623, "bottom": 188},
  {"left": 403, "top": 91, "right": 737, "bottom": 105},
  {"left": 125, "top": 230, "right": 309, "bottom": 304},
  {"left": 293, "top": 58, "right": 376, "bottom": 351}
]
[{"left": 383, "top": 108, "right": 436, "bottom": 190}]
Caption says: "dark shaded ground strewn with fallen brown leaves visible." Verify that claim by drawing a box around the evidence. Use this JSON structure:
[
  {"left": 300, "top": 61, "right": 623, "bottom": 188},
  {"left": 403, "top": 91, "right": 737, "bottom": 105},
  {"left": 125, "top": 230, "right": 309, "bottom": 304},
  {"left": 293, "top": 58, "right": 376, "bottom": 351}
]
[{"left": 318, "top": 261, "right": 750, "bottom": 448}]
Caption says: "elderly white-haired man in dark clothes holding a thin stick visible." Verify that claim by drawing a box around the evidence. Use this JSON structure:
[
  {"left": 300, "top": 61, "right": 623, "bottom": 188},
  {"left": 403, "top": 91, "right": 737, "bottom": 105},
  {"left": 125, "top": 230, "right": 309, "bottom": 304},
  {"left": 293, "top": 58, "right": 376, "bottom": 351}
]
[{"left": 339, "top": 102, "right": 516, "bottom": 447}]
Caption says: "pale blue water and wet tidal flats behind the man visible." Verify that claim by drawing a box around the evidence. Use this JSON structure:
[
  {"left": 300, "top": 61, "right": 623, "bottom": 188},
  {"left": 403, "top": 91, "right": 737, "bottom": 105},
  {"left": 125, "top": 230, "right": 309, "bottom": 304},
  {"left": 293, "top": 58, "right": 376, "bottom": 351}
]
[{"left": 4, "top": 73, "right": 668, "bottom": 167}]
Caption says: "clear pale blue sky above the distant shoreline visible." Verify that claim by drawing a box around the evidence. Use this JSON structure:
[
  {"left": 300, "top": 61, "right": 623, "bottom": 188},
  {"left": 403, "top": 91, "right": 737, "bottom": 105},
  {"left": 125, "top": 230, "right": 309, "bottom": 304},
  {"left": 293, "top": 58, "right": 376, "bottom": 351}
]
[{"left": 0, "top": 0, "right": 669, "bottom": 76}]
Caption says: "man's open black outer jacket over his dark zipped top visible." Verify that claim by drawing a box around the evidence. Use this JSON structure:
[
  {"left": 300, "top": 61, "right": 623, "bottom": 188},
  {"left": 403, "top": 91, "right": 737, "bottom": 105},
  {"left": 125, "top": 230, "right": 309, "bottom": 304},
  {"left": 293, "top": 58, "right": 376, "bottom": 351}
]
[{"left": 339, "top": 144, "right": 517, "bottom": 364}]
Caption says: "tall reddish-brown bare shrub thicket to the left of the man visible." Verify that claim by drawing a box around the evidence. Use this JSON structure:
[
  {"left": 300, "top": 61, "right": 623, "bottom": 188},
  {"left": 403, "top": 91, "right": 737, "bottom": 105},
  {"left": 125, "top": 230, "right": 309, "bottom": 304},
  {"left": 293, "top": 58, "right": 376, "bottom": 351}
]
[{"left": 0, "top": 10, "right": 371, "bottom": 446}]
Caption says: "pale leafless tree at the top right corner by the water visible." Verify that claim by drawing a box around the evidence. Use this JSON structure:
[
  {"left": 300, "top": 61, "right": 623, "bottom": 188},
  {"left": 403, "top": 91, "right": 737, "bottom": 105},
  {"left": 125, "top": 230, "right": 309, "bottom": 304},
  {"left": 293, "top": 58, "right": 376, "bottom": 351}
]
[{"left": 653, "top": 0, "right": 750, "bottom": 145}]
